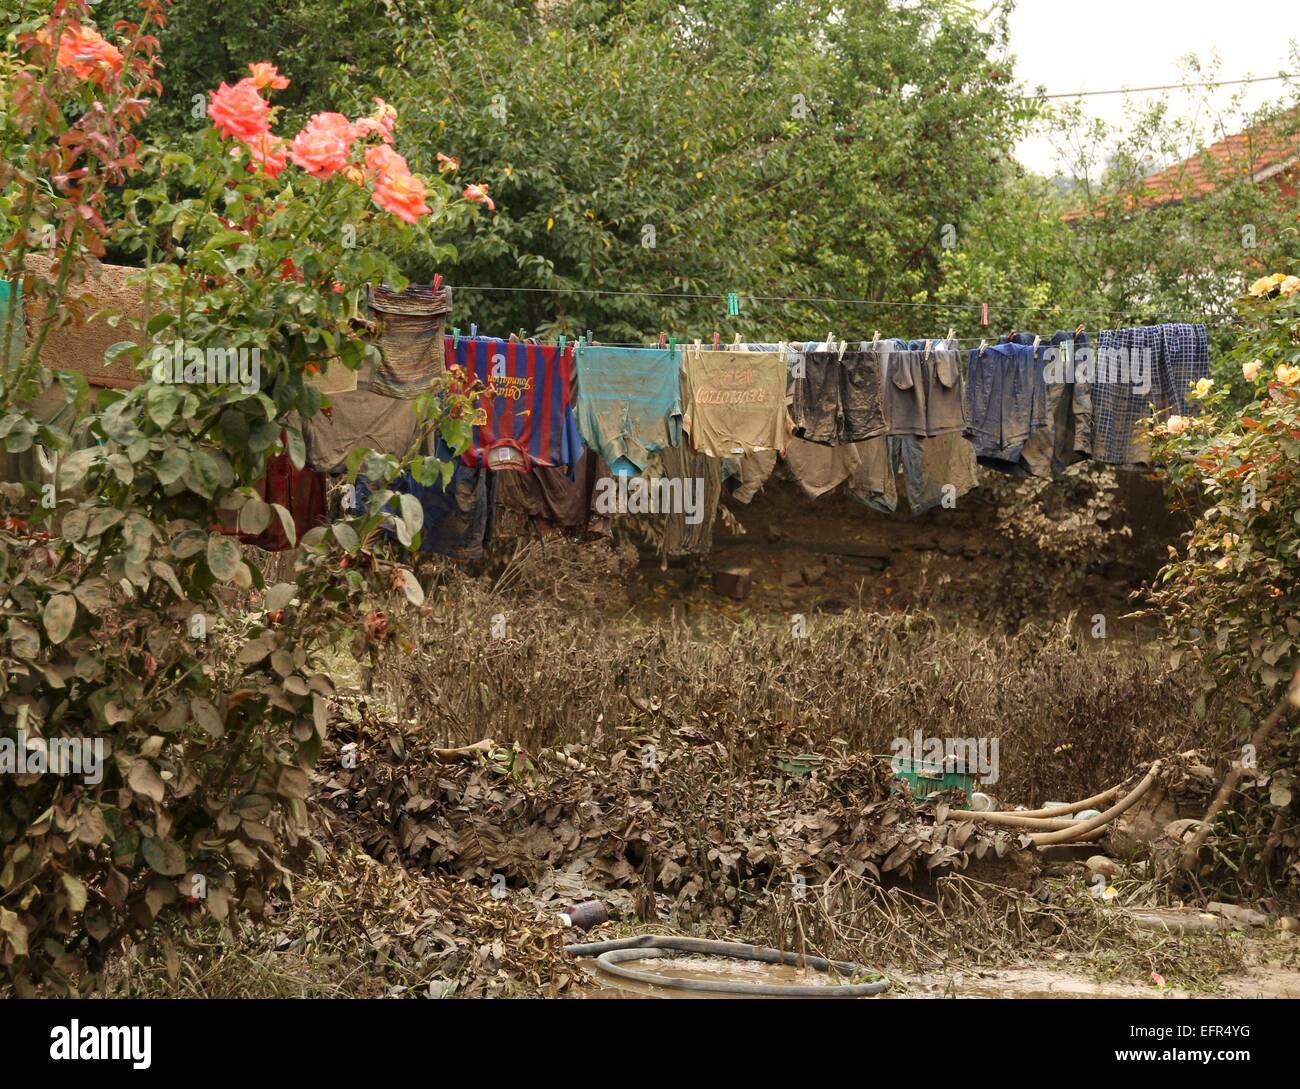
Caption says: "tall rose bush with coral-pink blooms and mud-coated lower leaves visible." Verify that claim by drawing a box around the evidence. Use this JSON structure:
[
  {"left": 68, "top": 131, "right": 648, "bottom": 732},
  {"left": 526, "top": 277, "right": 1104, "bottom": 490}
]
[{"left": 0, "top": 0, "right": 480, "bottom": 993}]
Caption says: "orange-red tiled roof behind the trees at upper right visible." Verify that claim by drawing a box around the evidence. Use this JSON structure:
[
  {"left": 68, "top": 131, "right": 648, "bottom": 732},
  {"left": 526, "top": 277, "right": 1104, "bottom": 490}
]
[{"left": 1062, "top": 110, "right": 1300, "bottom": 222}]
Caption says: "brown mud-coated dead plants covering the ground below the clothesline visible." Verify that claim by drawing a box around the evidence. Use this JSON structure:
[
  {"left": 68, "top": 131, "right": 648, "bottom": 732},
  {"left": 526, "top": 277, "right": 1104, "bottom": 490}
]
[{"left": 107, "top": 541, "right": 1295, "bottom": 995}]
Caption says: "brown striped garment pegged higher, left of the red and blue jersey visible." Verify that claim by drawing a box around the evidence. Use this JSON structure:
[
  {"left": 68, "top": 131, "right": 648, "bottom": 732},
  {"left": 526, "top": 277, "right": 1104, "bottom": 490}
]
[{"left": 369, "top": 283, "right": 451, "bottom": 400}]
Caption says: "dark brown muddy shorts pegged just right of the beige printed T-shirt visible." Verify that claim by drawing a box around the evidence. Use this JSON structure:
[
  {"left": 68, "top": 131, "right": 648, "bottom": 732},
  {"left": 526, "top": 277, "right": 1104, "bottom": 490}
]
[{"left": 790, "top": 346, "right": 887, "bottom": 446}]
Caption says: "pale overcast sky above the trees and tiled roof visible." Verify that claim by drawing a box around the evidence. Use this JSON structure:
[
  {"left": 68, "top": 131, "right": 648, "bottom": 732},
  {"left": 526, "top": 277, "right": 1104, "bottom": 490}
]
[{"left": 1011, "top": 0, "right": 1300, "bottom": 174}]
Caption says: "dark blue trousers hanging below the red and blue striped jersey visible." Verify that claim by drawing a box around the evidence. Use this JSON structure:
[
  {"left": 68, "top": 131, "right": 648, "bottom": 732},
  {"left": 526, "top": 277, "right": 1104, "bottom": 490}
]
[{"left": 354, "top": 439, "right": 497, "bottom": 560}]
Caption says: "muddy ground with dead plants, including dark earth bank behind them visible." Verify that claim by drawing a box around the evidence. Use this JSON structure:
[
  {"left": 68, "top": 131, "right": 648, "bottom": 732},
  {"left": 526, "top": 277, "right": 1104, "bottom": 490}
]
[{"left": 108, "top": 467, "right": 1300, "bottom": 997}]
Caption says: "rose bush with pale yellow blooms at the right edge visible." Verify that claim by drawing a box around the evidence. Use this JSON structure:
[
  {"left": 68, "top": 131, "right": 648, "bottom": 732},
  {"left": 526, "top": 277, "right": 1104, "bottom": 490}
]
[{"left": 1154, "top": 273, "right": 1300, "bottom": 700}]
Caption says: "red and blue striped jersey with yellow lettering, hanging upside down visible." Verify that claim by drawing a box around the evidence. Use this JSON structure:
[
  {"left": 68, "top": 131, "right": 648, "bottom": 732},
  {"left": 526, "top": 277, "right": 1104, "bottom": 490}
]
[{"left": 445, "top": 337, "right": 582, "bottom": 473}]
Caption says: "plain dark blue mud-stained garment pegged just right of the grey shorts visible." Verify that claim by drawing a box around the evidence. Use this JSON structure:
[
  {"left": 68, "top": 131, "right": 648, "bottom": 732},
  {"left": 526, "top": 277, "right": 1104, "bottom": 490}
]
[{"left": 966, "top": 334, "right": 1048, "bottom": 476}]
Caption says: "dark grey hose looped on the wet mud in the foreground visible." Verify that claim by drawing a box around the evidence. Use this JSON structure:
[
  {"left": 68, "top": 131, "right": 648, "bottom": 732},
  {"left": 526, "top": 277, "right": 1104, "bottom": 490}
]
[{"left": 564, "top": 934, "right": 889, "bottom": 998}]
